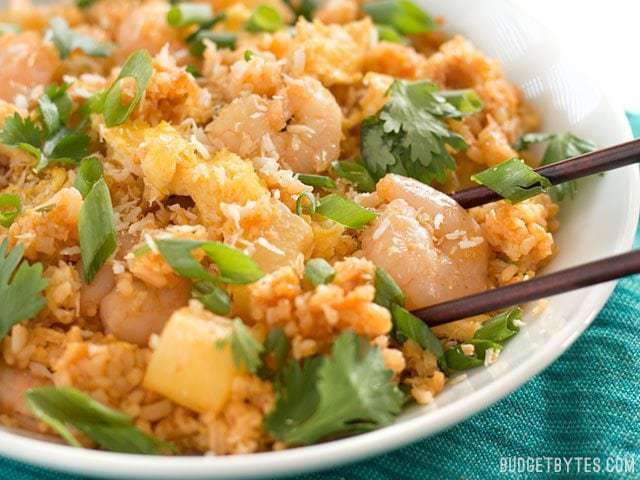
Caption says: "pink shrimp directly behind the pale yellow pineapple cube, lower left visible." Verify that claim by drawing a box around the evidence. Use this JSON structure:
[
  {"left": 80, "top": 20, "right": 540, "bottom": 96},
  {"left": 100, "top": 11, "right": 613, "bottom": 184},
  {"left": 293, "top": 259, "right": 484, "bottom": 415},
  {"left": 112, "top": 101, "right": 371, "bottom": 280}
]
[{"left": 100, "top": 275, "right": 191, "bottom": 346}]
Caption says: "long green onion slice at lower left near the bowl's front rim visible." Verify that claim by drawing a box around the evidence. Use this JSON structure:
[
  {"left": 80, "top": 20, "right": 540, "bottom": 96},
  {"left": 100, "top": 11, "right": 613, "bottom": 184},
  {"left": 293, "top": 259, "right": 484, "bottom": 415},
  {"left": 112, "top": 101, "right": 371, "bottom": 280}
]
[{"left": 25, "top": 387, "right": 176, "bottom": 454}]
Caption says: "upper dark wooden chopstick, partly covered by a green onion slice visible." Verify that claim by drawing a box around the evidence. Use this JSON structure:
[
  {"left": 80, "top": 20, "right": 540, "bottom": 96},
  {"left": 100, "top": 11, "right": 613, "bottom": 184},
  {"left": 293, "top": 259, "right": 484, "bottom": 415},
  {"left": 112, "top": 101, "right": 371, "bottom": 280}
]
[{"left": 451, "top": 139, "right": 640, "bottom": 208}]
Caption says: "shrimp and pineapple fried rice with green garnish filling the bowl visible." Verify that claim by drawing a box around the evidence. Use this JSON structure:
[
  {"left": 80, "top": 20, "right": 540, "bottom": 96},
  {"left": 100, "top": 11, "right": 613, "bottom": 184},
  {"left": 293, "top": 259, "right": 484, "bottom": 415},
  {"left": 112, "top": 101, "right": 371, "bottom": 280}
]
[{"left": 0, "top": 0, "right": 593, "bottom": 455}]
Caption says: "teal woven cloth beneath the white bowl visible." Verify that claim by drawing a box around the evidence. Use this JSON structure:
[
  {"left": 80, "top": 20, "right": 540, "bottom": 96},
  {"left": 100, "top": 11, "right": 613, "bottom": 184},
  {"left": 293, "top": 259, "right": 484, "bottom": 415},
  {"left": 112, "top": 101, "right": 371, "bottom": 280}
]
[{"left": 0, "top": 115, "right": 640, "bottom": 480}]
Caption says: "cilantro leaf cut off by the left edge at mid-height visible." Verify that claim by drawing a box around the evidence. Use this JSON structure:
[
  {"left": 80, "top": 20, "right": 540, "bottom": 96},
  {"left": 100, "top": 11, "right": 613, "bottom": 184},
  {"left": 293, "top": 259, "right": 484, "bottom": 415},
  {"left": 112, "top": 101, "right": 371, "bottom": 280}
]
[{"left": 0, "top": 239, "right": 48, "bottom": 340}]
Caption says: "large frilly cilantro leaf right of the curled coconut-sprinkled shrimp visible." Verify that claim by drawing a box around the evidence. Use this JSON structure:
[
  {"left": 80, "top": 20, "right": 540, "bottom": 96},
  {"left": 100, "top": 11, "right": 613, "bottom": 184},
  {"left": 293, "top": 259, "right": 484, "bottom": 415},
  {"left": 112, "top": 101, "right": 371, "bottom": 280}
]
[{"left": 360, "top": 80, "right": 477, "bottom": 183}]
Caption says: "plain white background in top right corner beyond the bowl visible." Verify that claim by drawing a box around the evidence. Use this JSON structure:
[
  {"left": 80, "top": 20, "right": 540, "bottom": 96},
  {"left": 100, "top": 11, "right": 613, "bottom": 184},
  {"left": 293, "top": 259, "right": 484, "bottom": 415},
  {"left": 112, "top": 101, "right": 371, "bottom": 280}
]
[{"left": 512, "top": 0, "right": 640, "bottom": 112}]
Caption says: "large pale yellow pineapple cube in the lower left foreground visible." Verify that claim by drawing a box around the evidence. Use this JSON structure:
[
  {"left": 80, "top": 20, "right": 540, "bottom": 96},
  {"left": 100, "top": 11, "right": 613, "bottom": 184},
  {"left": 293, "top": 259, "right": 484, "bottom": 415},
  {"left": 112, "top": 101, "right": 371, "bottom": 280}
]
[{"left": 143, "top": 302, "right": 239, "bottom": 413}]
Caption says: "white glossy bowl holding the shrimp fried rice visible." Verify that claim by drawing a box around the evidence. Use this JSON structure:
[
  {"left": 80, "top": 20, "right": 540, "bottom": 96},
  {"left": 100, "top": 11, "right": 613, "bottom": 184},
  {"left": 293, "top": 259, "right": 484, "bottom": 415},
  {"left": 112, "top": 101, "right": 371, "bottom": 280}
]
[{"left": 0, "top": 0, "right": 640, "bottom": 480}]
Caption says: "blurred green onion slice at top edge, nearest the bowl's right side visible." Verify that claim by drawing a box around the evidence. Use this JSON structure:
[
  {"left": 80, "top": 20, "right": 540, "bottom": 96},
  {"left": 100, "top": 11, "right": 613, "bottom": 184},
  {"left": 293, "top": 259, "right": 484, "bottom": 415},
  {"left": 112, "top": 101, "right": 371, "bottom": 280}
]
[{"left": 362, "top": 0, "right": 438, "bottom": 35}]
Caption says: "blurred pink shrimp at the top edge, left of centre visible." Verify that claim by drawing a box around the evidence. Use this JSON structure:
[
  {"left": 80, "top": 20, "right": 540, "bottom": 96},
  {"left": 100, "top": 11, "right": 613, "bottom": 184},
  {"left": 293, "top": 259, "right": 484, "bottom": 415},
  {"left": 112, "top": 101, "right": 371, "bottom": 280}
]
[{"left": 116, "top": 1, "right": 181, "bottom": 61}]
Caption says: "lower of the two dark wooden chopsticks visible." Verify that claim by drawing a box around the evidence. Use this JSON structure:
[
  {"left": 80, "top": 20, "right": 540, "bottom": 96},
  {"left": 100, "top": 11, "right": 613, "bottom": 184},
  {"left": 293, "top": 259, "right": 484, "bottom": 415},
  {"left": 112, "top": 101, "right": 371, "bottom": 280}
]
[{"left": 412, "top": 250, "right": 640, "bottom": 326}]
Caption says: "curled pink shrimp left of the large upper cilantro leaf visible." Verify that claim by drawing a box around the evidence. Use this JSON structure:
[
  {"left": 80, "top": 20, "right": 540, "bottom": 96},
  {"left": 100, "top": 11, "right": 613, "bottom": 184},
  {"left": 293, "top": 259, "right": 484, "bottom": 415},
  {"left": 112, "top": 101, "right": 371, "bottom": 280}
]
[{"left": 206, "top": 77, "right": 342, "bottom": 173}]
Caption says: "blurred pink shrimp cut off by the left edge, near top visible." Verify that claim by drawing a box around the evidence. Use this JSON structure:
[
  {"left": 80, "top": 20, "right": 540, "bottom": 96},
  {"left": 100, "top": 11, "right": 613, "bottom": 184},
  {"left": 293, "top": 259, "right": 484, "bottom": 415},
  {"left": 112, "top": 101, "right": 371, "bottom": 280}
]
[{"left": 0, "top": 31, "right": 60, "bottom": 102}]
